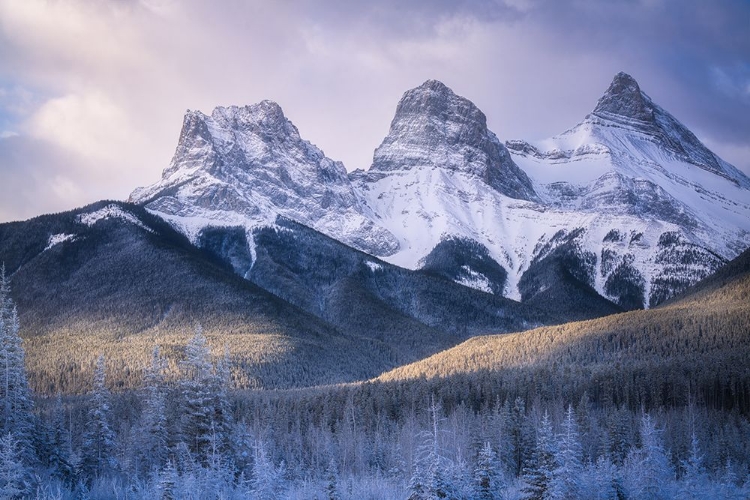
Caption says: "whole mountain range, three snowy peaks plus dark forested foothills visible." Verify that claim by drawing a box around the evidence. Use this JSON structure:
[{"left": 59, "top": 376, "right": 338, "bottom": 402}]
[{"left": 10, "top": 73, "right": 750, "bottom": 398}]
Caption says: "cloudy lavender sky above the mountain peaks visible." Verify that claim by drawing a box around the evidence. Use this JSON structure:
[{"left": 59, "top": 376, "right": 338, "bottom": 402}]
[{"left": 0, "top": 0, "right": 750, "bottom": 221}]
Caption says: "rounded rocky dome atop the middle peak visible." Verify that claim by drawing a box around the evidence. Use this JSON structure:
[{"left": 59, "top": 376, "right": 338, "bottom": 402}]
[{"left": 370, "top": 80, "right": 536, "bottom": 200}]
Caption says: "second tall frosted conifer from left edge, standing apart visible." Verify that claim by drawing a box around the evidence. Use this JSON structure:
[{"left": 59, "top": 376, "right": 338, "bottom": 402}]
[{"left": 83, "top": 355, "right": 117, "bottom": 477}]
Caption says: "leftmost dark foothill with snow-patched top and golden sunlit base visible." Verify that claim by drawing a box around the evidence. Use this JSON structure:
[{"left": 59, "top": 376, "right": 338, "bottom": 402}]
[{"left": 0, "top": 202, "right": 418, "bottom": 394}]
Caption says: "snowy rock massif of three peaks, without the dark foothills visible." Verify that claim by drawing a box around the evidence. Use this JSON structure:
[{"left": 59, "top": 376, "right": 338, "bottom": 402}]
[{"left": 132, "top": 73, "right": 750, "bottom": 310}]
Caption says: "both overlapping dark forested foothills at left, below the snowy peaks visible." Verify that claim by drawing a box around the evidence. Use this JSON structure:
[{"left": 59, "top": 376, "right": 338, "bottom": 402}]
[{"left": 0, "top": 201, "right": 560, "bottom": 394}]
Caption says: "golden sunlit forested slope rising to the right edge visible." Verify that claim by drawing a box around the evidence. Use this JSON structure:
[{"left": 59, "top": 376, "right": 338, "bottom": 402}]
[{"left": 377, "top": 251, "right": 750, "bottom": 415}]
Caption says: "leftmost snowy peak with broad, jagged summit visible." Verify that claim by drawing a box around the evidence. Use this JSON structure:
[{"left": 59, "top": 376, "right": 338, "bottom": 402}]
[{"left": 130, "top": 101, "right": 396, "bottom": 255}]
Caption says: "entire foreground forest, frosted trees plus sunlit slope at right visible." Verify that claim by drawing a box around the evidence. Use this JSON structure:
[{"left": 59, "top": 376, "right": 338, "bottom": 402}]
[{"left": 0, "top": 245, "right": 750, "bottom": 500}]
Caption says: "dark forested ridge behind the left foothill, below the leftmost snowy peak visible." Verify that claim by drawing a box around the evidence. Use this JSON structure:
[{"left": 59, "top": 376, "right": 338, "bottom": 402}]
[{"left": 203, "top": 218, "right": 562, "bottom": 344}]
